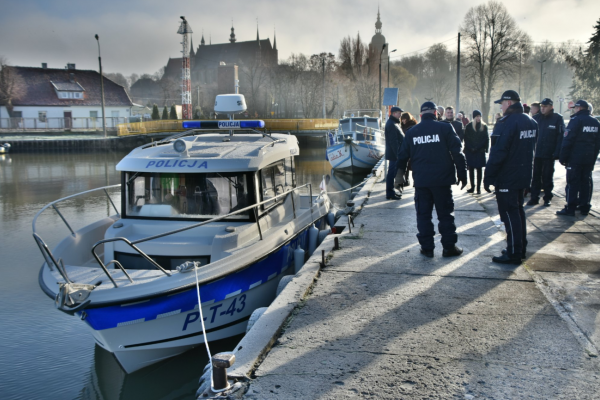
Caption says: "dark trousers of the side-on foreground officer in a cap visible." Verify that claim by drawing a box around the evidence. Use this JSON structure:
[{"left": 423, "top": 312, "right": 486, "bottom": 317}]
[{"left": 496, "top": 189, "right": 527, "bottom": 256}]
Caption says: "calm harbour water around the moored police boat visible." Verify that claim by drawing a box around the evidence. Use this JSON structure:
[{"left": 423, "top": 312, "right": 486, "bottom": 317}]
[{"left": 0, "top": 138, "right": 363, "bottom": 400}]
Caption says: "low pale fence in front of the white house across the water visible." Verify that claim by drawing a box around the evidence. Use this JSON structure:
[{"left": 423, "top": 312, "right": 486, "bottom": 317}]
[{"left": 0, "top": 117, "right": 127, "bottom": 131}]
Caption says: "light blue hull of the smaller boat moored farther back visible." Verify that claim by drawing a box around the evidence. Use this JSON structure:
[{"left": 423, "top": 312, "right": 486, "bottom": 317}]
[{"left": 327, "top": 142, "right": 385, "bottom": 173}]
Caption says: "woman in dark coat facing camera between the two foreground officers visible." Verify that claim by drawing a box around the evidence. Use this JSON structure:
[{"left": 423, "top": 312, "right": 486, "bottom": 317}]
[{"left": 464, "top": 110, "right": 490, "bottom": 194}]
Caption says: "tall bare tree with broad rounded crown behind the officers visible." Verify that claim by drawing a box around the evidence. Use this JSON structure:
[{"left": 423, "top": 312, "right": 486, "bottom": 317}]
[{"left": 460, "top": 0, "right": 531, "bottom": 122}]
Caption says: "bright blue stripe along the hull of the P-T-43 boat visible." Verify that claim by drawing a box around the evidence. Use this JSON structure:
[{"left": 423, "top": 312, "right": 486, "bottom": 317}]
[{"left": 85, "top": 225, "right": 322, "bottom": 330}]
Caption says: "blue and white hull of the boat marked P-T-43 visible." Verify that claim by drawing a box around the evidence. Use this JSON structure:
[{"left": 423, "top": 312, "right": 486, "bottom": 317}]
[{"left": 78, "top": 225, "right": 316, "bottom": 373}]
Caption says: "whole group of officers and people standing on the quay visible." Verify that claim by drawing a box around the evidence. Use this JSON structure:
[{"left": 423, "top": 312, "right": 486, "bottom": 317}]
[{"left": 385, "top": 90, "right": 600, "bottom": 265}]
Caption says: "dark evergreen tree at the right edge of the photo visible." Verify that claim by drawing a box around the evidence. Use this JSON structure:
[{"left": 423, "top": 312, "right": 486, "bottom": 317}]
[{"left": 566, "top": 19, "right": 600, "bottom": 107}]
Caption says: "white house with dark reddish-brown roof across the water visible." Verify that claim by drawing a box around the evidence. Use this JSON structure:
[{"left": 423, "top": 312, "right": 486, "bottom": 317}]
[{"left": 0, "top": 63, "right": 133, "bottom": 129}]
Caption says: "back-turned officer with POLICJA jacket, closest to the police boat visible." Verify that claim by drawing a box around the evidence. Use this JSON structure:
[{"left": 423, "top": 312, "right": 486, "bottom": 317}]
[{"left": 398, "top": 101, "right": 467, "bottom": 257}]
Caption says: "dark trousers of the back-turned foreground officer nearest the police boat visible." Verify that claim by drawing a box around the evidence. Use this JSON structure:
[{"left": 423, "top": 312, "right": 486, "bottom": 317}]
[{"left": 415, "top": 186, "right": 458, "bottom": 250}]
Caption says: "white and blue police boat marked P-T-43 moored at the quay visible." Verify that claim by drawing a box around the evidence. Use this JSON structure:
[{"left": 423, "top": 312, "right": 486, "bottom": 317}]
[{"left": 33, "top": 95, "right": 333, "bottom": 373}]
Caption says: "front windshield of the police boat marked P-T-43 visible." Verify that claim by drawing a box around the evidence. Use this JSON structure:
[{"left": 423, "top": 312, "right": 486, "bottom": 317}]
[{"left": 124, "top": 172, "right": 250, "bottom": 220}]
